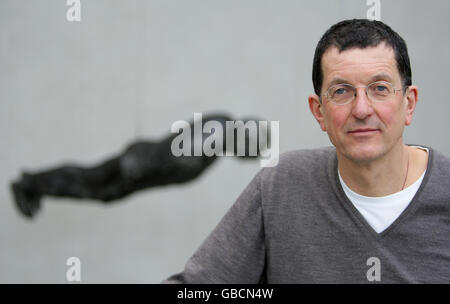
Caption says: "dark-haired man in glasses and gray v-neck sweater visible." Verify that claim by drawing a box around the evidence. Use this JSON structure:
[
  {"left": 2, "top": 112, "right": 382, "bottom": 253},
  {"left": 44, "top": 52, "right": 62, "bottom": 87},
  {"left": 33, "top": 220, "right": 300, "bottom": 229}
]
[{"left": 165, "top": 20, "right": 450, "bottom": 283}]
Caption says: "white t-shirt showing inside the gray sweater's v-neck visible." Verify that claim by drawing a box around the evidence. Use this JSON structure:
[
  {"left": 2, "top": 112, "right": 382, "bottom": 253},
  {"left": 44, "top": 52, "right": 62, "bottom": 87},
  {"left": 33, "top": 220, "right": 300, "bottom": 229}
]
[{"left": 338, "top": 147, "right": 428, "bottom": 233}]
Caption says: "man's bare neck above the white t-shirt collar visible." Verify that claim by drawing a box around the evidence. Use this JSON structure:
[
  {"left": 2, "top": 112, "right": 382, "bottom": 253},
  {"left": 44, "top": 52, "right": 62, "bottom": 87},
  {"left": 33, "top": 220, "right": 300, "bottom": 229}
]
[{"left": 337, "top": 143, "right": 427, "bottom": 197}]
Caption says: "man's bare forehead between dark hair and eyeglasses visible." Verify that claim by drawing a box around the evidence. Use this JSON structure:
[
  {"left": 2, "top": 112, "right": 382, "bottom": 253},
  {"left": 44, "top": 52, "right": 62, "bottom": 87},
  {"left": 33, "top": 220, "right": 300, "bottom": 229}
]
[{"left": 322, "top": 43, "right": 398, "bottom": 81}]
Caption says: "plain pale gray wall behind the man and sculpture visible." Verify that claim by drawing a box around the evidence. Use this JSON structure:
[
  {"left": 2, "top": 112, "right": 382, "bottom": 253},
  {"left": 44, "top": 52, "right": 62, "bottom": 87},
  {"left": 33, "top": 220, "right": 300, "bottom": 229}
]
[{"left": 0, "top": 0, "right": 450, "bottom": 283}]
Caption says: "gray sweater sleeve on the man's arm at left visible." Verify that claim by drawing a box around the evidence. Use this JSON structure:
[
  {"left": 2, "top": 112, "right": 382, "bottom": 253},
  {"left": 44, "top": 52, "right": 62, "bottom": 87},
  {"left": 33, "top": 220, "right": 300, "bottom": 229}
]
[{"left": 163, "top": 171, "right": 265, "bottom": 284}]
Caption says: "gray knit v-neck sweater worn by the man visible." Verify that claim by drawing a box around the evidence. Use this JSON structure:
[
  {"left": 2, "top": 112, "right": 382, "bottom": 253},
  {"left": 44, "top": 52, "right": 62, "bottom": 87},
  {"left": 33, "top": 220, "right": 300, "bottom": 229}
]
[{"left": 164, "top": 147, "right": 450, "bottom": 283}]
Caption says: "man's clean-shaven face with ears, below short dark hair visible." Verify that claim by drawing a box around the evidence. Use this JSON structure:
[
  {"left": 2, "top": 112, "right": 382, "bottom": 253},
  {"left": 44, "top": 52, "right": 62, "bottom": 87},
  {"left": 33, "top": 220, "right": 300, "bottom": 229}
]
[{"left": 309, "top": 43, "right": 417, "bottom": 162}]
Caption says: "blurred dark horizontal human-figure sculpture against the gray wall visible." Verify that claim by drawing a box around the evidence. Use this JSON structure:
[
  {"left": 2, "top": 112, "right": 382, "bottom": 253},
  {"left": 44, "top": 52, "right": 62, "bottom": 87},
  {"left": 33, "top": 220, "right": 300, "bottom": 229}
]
[{"left": 11, "top": 114, "right": 269, "bottom": 218}]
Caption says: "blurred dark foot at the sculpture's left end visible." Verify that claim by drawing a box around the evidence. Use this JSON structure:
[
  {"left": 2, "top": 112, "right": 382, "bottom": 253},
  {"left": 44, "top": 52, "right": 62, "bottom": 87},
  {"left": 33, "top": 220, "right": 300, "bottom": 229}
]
[{"left": 11, "top": 181, "right": 41, "bottom": 218}]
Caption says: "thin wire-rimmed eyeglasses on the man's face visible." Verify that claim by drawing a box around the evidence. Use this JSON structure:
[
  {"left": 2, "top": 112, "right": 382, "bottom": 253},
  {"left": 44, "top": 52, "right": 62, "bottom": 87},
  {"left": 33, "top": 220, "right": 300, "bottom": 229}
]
[{"left": 320, "top": 81, "right": 404, "bottom": 105}]
